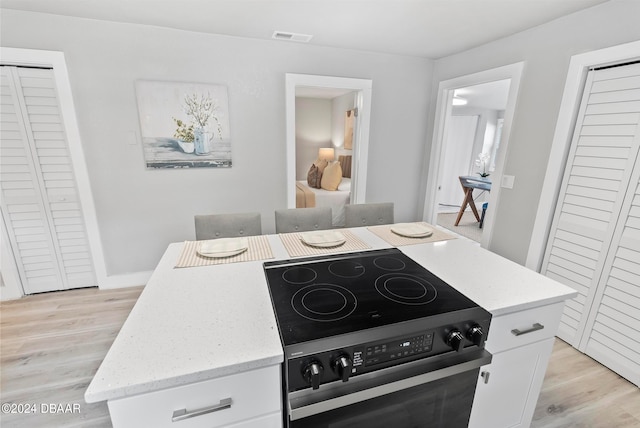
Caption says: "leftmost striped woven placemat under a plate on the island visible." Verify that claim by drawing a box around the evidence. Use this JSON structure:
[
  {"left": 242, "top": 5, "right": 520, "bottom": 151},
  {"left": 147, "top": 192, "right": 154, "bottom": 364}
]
[{"left": 175, "top": 236, "right": 273, "bottom": 268}]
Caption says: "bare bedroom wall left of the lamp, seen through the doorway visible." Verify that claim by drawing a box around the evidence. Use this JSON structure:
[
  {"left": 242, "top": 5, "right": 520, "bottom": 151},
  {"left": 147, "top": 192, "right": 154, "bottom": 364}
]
[{"left": 296, "top": 97, "right": 331, "bottom": 180}]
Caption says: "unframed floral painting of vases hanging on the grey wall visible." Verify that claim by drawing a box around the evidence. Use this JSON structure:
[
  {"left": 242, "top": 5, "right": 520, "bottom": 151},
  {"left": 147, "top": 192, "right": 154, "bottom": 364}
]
[{"left": 136, "top": 80, "right": 232, "bottom": 168}]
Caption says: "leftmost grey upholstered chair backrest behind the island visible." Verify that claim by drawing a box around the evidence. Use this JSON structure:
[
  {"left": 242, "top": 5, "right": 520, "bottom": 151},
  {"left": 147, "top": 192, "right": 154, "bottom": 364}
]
[{"left": 194, "top": 213, "right": 262, "bottom": 241}]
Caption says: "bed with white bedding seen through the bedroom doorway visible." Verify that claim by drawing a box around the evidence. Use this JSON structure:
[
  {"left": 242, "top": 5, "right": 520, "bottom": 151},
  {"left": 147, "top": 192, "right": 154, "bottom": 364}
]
[{"left": 296, "top": 156, "right": 351, "bottom": 226}]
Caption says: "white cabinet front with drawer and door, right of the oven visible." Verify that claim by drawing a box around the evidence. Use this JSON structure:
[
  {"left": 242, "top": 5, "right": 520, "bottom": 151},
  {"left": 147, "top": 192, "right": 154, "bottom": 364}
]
[{"left": 469, "top": 303, "right": 564, "bottom": 428}]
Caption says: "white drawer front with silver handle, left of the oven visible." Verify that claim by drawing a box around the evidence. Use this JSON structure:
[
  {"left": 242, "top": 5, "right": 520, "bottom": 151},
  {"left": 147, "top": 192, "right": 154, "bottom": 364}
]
[{"left": 108, "top": 365, "right": 282, "bottom": 428}]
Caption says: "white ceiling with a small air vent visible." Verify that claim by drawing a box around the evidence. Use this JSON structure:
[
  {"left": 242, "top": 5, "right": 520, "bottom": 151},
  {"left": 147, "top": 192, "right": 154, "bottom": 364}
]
[{"left": 1, "top": 0, "right": 610, "bottom": 59}]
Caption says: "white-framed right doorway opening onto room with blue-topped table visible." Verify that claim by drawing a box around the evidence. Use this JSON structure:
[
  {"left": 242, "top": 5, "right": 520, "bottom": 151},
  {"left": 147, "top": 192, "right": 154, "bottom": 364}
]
[{"left": 423, "top": 63, "right": 523, "bottom": 248}]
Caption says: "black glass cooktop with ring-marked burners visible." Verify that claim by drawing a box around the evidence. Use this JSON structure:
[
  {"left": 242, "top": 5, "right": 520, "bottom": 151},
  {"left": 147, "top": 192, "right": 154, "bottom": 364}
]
[{"left": 264, "top": 248, "right": 478, "bottom": 346}]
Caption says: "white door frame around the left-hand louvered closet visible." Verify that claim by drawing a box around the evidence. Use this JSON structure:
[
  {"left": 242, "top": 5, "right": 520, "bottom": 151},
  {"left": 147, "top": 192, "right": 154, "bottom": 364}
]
[{"left": 0, "top": 47, "right": 107, "bottom": 289}]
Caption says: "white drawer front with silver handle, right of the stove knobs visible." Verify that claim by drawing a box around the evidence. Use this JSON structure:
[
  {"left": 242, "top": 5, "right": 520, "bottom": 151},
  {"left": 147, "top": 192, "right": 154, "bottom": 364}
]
[{"left": 485, "top": 302, "right": 564, "bottom": 353}]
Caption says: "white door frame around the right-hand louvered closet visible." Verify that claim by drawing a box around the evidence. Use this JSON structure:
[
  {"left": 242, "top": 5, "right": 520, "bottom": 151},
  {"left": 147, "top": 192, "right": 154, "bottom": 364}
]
[{"left": 525, "top": 41, "right": 640, "bottom": 272}]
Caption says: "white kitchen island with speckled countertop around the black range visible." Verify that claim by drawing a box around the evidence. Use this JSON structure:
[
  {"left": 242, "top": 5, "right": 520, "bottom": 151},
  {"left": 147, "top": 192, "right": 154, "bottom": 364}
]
[{"left": 85, "top": 228, "right": 575, "bottom": 427}]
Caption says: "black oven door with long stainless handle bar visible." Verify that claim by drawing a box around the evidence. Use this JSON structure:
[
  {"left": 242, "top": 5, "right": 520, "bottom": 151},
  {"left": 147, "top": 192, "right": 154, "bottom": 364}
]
[{"left": 288, "top": 350, "right": 491, "bottom": 428}]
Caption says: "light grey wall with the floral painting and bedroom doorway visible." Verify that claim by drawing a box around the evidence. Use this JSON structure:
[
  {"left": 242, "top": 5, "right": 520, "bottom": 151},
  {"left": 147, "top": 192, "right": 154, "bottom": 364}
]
[{"left": 0, "top": 9, "right": 433, "bottom": 276}]
